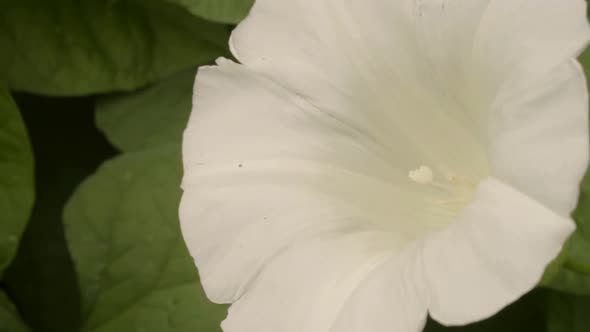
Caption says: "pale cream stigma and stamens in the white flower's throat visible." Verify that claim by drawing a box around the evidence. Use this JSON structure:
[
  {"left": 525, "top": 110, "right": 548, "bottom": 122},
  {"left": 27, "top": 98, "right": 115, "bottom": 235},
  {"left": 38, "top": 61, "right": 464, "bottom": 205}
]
[{"left": 408, "top": 166, "right": 476, "bottom": 212}]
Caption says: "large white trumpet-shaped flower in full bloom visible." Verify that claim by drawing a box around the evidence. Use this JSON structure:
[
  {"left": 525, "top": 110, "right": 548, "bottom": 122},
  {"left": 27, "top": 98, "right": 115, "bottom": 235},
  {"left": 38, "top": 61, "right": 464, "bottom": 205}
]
[{"left": 180, "top": 0, "right": 590, "bottom": 332}]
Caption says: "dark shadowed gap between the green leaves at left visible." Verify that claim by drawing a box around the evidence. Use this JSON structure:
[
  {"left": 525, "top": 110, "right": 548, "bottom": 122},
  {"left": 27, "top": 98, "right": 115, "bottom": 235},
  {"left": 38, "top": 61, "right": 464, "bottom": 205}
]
[{"left": 2, "top": 94, "right": 116, "bottom": 332}]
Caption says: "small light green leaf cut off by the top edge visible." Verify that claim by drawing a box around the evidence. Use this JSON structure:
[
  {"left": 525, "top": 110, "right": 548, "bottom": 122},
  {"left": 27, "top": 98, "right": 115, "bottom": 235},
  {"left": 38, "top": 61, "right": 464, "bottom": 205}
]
[{"left": 168, "top": 0, "right": 254, "bottom": 23}]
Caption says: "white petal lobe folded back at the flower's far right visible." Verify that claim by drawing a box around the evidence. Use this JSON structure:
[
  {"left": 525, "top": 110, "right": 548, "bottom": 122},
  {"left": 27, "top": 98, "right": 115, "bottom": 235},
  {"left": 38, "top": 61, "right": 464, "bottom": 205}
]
[{"left": 490, "top": 60, "right": 590, "bottom": 216}]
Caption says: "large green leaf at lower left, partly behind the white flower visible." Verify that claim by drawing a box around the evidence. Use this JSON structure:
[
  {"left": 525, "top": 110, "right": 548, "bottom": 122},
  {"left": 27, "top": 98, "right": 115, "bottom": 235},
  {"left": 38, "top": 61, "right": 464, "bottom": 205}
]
[{"left": 64, "top": 144, "right": 225, "bottom": 332}]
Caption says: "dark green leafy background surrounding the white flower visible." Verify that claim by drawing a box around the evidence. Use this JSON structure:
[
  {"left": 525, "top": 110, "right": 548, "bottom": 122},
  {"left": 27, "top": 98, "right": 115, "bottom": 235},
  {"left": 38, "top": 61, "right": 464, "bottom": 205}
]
[{"left": 0, "top": 0, "right": 590, "bottom": 332}]
